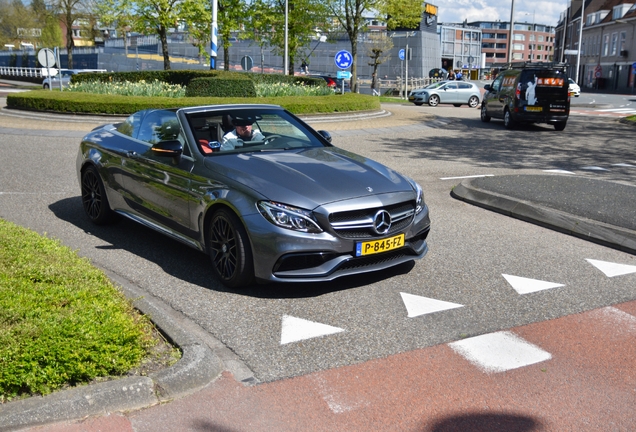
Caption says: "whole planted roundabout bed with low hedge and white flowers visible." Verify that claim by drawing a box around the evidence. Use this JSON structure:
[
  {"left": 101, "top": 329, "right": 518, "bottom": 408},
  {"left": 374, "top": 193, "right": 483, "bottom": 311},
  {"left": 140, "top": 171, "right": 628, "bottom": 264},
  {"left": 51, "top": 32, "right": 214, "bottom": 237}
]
[{"left": 7, "top": 71, "right": 380, "bottom": 115}]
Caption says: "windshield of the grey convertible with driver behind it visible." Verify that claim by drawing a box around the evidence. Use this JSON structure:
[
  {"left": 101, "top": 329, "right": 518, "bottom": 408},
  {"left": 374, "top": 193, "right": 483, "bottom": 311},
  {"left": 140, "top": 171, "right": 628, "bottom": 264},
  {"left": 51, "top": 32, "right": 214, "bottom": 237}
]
[{"left": 181, "top": 108, "right": 328, "bottom": 156}]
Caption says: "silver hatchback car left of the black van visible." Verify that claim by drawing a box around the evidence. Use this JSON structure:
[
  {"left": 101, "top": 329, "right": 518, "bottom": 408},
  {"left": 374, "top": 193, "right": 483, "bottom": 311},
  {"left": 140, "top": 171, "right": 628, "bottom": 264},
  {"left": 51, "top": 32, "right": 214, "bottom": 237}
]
[{"left": 409, "top": 81, "right": 481, "bottom": 108}]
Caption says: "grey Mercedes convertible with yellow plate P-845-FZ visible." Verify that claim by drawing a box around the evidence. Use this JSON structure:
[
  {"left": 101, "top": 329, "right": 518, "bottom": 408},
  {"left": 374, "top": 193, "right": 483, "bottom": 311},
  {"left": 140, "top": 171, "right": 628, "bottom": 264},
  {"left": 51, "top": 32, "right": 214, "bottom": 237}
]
[{"left": 77, "top": 105, "right": 430, "bottom": 287}]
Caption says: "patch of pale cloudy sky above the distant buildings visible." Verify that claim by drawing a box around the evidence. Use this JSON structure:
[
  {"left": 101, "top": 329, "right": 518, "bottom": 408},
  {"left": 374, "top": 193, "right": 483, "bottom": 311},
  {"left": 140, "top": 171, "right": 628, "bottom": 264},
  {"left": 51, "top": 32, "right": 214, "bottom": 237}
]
[{"left": 438, "top": 0, "right": 569, "bottom": 26}]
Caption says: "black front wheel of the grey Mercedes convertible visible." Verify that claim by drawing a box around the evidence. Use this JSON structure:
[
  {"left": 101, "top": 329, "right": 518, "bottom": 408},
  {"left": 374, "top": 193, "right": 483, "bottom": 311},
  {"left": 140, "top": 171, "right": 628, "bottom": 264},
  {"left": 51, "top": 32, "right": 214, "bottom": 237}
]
[{"left": 208, "top": 208, "right": 254, "bottom": 288}]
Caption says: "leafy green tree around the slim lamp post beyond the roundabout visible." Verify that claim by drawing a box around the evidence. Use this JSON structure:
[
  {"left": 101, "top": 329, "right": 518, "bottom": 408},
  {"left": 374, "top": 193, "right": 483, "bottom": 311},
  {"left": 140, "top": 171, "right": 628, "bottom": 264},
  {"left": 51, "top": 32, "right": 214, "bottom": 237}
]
[{"left": 253, "top": 0, "right": 329, "bottom": 75}]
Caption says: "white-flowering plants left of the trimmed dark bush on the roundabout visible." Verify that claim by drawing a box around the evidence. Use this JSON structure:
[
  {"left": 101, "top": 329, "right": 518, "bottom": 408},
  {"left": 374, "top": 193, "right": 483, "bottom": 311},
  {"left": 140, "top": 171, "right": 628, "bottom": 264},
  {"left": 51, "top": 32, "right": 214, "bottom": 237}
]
[{"left": 69, "top": 80, "right": 185, "bottom": 98}]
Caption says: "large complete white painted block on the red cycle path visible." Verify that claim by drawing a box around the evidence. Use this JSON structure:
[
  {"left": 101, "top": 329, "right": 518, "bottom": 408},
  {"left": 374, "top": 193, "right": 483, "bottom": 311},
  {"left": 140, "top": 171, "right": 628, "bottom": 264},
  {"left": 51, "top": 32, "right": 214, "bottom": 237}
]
[{"left": 448, "top": 331, "right": 552, "bottom": 372}]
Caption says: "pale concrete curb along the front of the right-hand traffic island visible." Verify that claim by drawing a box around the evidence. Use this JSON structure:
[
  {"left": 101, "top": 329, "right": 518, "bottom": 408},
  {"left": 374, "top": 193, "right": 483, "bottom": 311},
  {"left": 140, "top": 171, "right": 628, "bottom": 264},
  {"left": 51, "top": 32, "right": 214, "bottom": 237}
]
[{"left": 451, "top": 179, "right": 636, "bottom": 254}]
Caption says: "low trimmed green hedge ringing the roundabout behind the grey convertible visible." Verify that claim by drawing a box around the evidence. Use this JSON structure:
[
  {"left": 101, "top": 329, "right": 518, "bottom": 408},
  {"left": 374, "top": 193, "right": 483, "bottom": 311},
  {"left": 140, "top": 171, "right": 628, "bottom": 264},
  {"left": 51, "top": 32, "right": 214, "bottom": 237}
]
[{"left": 7, "top": 90, "right": 380, "bottom": 115}]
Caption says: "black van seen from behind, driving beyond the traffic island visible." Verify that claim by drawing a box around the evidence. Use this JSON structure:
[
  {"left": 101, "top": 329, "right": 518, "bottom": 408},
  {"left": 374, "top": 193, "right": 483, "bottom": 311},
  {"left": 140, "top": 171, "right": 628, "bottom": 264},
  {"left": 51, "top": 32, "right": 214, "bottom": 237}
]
[{"left": 481, "top": 62, "right": 570, "bottom": 131}]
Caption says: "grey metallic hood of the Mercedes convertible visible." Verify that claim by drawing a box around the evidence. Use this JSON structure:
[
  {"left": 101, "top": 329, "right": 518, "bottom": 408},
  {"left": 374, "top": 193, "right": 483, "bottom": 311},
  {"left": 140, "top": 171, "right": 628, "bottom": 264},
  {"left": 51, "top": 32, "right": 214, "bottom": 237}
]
[{"left": 205, "top": 147, "right": 413, "bottom": 210}]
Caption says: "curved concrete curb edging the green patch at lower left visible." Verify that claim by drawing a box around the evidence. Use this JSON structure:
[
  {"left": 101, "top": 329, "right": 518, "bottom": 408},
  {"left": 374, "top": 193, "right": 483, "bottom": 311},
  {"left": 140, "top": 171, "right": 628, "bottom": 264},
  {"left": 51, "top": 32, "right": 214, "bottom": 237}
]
[{"left": 0, "top": 271, "right": 224, "bottom": 431}]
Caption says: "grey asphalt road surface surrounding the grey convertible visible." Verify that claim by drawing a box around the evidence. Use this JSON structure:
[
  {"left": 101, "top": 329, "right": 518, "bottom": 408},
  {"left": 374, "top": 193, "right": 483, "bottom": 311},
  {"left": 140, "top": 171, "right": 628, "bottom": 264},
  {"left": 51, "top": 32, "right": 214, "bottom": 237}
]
[{"left": 0, "top": 102, "right": 636, "bottom": 388}]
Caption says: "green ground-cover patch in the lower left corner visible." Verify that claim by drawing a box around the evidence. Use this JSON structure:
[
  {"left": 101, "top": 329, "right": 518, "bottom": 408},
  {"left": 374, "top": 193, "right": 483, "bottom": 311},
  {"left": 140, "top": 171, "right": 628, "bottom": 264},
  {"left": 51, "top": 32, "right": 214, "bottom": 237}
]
[{"left": 0, "top": 219, "right": 178, "bottom": 403}]
